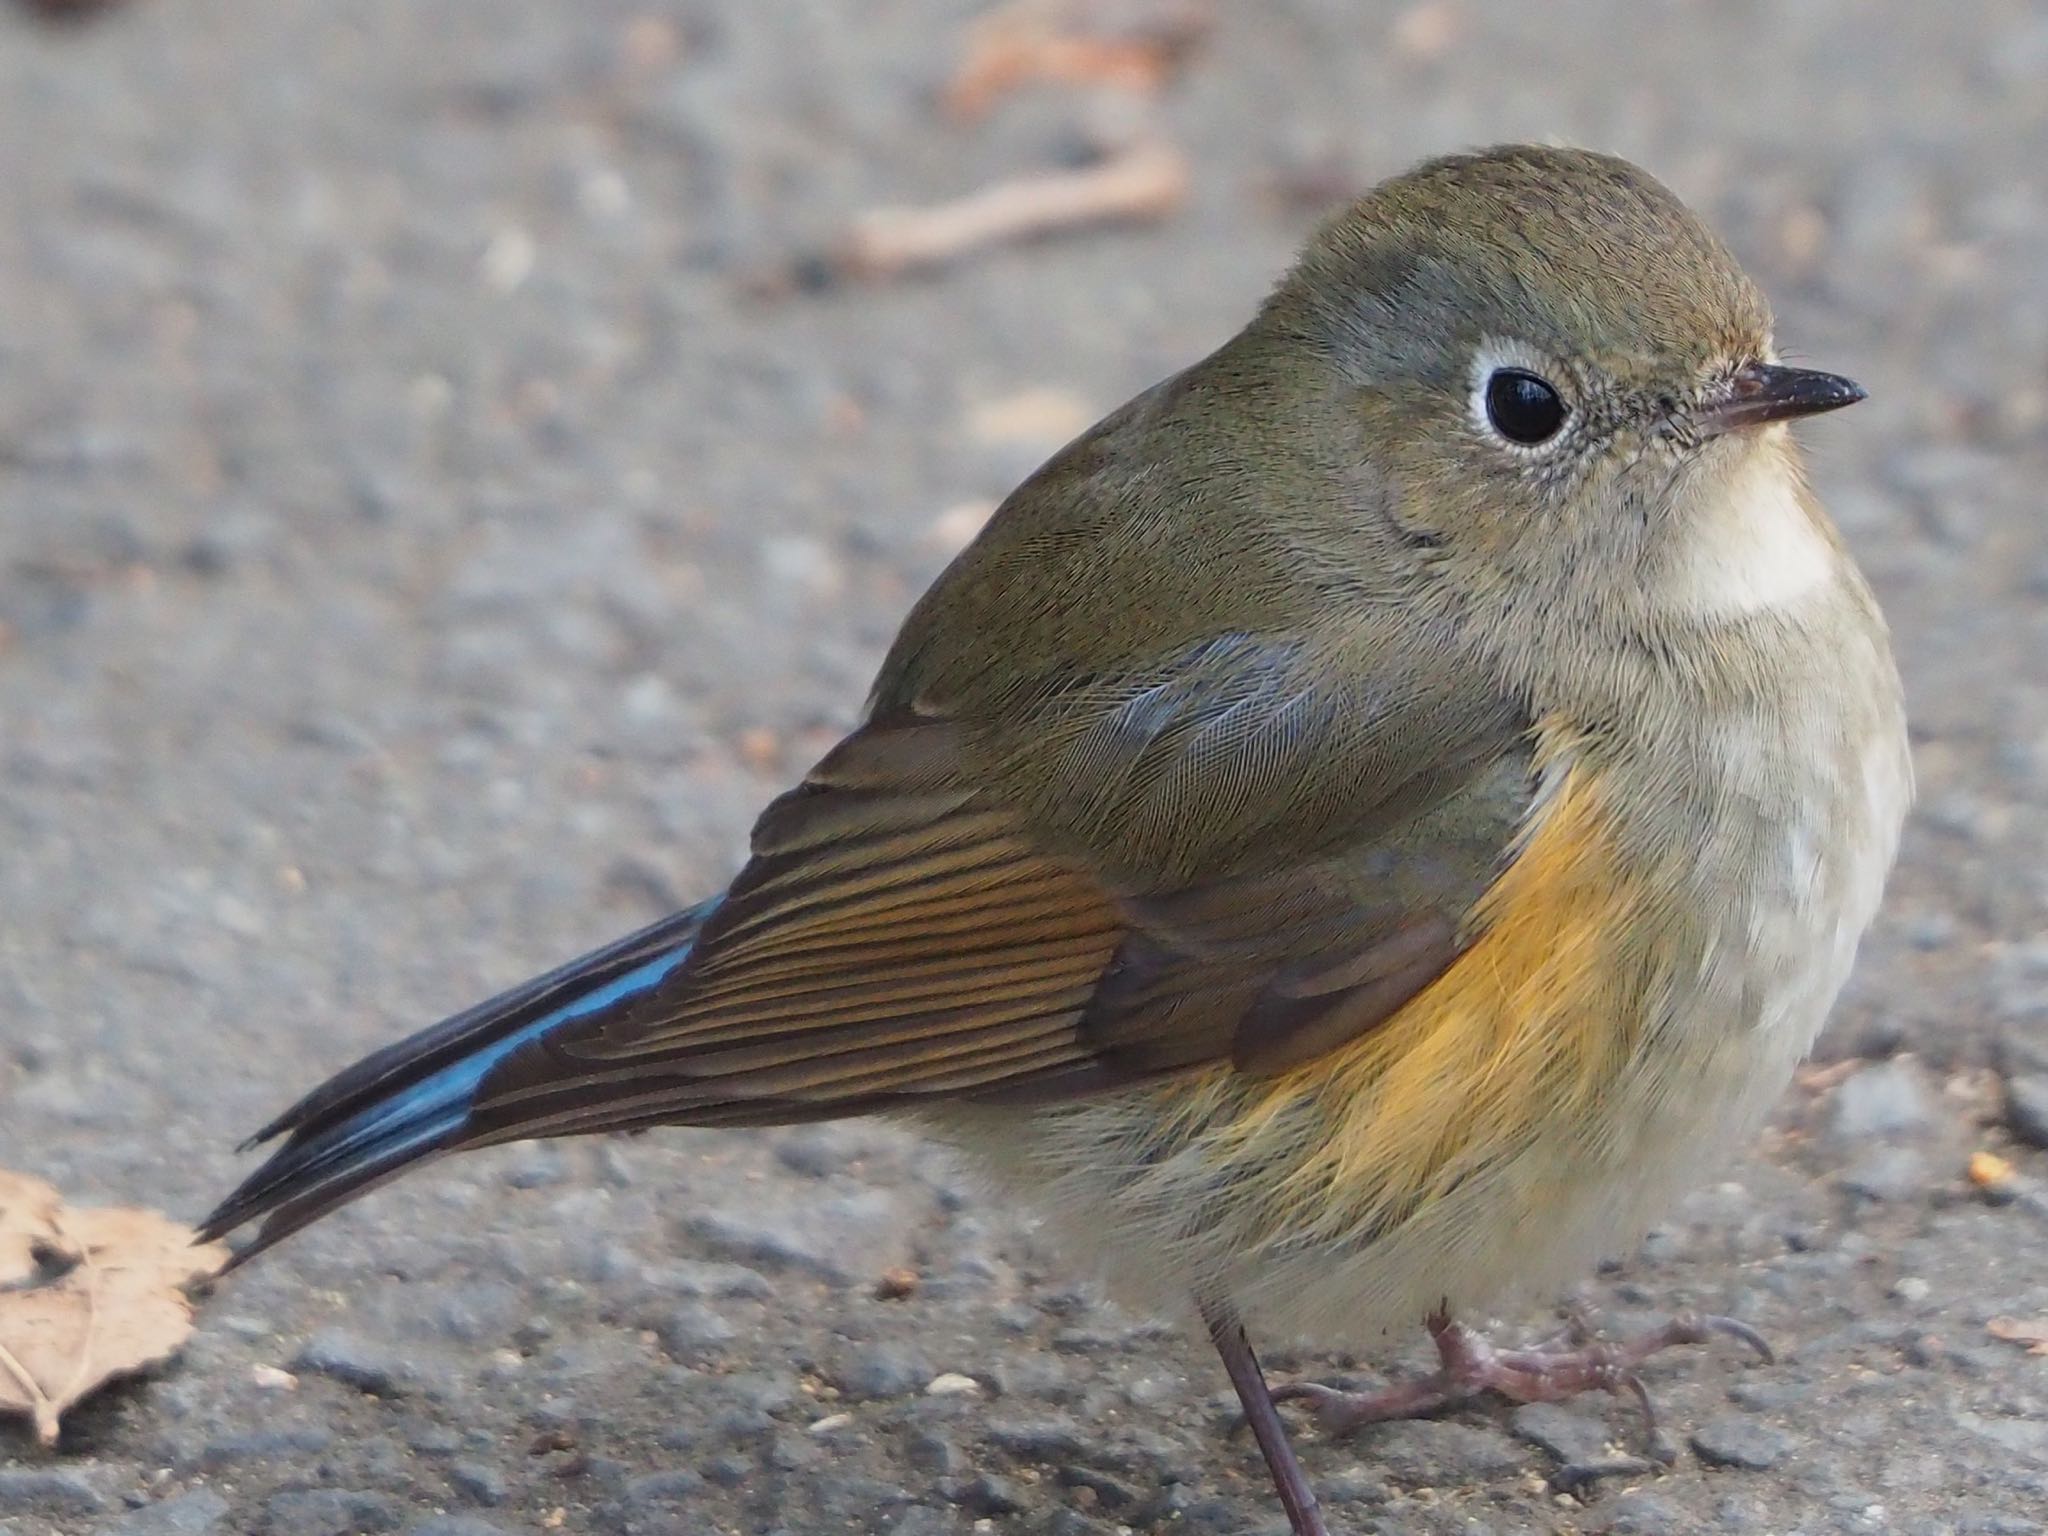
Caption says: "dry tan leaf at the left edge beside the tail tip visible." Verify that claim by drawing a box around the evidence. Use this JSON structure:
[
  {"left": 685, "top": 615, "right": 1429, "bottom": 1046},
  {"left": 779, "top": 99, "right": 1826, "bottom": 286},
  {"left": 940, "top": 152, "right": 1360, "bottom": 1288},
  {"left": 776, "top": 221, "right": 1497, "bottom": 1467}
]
[{"left": 0, "top": 1169, "right": 227, "bottom": 1446}]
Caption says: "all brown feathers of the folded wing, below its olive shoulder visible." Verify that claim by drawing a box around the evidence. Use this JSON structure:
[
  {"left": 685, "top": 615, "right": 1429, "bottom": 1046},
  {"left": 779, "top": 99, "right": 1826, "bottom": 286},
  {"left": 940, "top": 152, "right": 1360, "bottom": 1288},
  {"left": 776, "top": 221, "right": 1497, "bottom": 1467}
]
[{"left": 473, "top": 721, "right": 1524, "bottom": 1139}]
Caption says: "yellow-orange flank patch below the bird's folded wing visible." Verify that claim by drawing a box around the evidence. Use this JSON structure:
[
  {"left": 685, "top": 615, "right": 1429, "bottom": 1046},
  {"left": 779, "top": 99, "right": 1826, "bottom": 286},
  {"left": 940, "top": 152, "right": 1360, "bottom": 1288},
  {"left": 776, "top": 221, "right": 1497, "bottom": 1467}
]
[{"left": 1212, "top": 741, "right": 1642, "bottom": 1237}]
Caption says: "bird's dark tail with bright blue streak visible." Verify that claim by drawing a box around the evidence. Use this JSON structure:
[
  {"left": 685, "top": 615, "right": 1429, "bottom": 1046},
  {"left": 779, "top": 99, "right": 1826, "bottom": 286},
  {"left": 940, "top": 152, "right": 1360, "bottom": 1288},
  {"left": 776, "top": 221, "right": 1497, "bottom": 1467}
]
[{"left": 199, "top": 899, "right": 717, "bottom": 1268}]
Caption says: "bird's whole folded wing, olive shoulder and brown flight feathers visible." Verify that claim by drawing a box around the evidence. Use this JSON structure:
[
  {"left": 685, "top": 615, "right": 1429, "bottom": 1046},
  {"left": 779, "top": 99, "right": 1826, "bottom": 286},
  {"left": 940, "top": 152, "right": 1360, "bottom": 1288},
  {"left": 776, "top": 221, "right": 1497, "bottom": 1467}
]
[{"left": 463, "top": 635, "right": 1530, "bottom": 1141}]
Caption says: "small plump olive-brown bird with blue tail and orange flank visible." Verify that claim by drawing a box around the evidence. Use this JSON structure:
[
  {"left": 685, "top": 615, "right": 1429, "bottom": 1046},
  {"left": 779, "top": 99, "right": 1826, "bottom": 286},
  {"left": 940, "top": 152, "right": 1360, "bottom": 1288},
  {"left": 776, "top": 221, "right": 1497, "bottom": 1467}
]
[{"left": 203, "top": 145, "right": 1911, "bottom": 1536}]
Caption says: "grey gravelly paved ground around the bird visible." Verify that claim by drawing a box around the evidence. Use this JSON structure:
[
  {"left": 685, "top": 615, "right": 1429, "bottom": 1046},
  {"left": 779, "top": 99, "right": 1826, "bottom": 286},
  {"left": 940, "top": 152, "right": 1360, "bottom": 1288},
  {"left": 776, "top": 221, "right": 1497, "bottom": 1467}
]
[{"left": 0, "top": 0, "right": 2048, "bottom": 1536}]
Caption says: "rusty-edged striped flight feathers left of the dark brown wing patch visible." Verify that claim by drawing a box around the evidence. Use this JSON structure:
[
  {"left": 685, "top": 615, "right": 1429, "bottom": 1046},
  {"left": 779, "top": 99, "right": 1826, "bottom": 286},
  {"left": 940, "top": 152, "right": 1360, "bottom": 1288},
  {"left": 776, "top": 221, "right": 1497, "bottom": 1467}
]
[{"left": 475, "top": 725, "right": 1126, "bottom": 1135}]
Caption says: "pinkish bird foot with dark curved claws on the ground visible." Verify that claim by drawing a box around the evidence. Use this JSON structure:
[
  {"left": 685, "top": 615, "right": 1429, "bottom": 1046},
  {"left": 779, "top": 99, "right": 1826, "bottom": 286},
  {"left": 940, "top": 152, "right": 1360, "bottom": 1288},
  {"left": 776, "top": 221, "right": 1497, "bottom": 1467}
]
[{"left": 1274, "top": 1313, "right": 1772, "bottom": 1460}]
